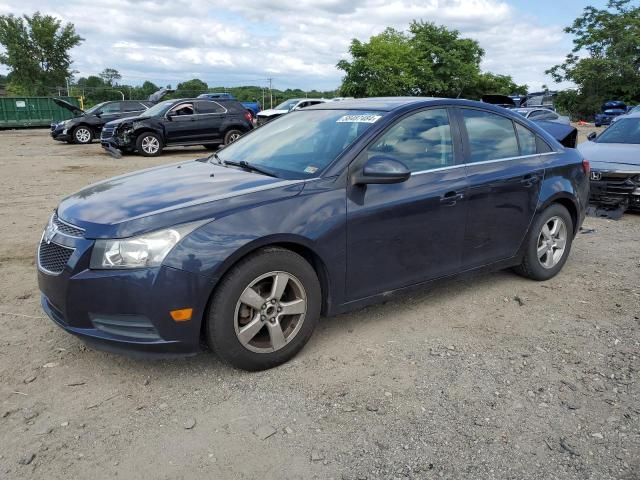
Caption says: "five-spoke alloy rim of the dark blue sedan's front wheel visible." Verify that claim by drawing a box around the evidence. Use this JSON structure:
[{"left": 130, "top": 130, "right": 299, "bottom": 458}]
[{"left": 234, "top": 271, "right": 307, "bottom": 353}]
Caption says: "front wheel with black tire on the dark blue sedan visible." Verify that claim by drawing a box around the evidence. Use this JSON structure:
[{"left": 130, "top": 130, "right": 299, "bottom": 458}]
[{"left": 206, "top": 248, "right": 321, "bottom": 371}]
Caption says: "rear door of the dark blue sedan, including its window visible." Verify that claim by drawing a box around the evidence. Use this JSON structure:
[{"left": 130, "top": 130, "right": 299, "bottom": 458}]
[{"left": 457, "top": 108, "right": 544, "bottom": 269}]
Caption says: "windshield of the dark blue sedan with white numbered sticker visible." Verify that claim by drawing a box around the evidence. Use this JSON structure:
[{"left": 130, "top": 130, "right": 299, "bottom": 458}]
[{"left": 211, "top": 110, "right": 384, "bottom": 180}]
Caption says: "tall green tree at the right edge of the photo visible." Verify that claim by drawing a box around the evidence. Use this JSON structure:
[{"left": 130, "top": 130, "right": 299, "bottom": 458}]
[{"left": 547, "top": 0, "right": 640, "bottom": 118}]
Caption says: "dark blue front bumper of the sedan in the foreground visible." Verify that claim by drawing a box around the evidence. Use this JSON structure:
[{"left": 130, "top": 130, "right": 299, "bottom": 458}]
[{"left": 37, "top": 234, "right": 213, "bottom": 356}]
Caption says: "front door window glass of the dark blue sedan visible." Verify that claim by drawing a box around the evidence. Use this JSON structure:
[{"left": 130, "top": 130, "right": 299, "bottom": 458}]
[{"left": 367, "top": 108, "right": 455, "bottom": 173}]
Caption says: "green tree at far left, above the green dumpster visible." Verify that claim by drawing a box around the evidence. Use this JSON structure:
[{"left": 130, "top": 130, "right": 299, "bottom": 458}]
[{"left": 0, "top": 12, "right": 83, "bottom": 95}]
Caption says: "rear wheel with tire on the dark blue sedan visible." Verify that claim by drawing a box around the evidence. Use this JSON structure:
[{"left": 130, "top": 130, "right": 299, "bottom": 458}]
[{"left": 515, "top": 203, "right": 573, "bottom": 281}]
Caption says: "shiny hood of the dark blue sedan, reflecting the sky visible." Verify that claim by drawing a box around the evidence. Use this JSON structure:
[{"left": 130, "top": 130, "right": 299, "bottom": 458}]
[{"left": 58, "top": 159, "right": 304, "bottom": 238}]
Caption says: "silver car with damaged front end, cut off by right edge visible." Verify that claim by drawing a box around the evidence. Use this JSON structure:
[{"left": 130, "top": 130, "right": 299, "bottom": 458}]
[{"left": 578, "top": 112, "right": 640, "bottom": 211}]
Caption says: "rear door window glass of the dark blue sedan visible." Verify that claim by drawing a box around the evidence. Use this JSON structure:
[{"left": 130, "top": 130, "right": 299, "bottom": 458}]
[{"left": 462, "top": 109, "right": 520, "bottom": 163}]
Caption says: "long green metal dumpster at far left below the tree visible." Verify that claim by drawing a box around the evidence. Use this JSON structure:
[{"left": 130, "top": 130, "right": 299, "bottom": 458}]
[{"left": 0, "top": 97, "right": 80, "bottom": 128}]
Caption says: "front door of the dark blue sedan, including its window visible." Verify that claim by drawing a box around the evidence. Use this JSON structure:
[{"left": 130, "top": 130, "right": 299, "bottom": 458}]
[{"left": 347, "top": 108, "right": 467, "bottom": 301}]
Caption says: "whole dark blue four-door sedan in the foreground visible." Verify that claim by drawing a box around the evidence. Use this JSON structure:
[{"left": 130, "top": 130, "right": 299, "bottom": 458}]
[{"left": 37, "top": 98, "right": 589, "bottom": 370}]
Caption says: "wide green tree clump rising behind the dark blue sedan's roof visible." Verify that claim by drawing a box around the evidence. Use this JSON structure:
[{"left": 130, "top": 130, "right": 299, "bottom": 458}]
[{"left": 337, "top": 21, "right": 526, "bottom": 98}]
